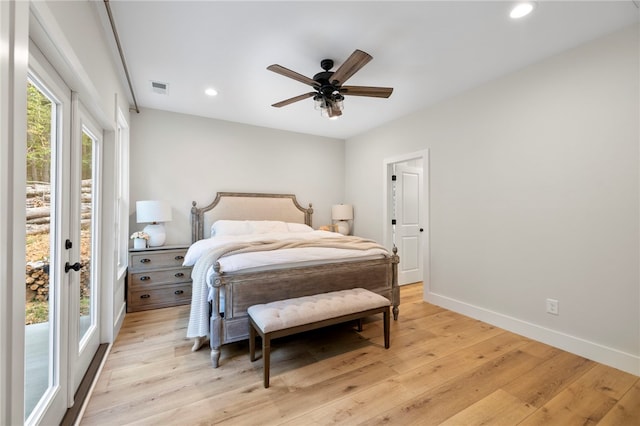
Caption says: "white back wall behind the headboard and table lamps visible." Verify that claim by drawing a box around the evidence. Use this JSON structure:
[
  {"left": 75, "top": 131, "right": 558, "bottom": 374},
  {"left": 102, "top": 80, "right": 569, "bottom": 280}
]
[{"left": 130, "top": 109, "right": 344, "bottom": 244}]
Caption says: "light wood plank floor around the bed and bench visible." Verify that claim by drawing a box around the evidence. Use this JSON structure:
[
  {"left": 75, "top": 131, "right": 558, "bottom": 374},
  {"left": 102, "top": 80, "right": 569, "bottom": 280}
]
[{"left": 81, "top": 285, "right": 640, "bottom": 426}]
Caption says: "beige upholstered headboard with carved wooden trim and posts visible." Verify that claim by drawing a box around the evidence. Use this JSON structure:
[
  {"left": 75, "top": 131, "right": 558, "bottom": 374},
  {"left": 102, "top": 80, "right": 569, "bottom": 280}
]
[{"left": 191, "top": 192, "right": 313, "bottom": 242}]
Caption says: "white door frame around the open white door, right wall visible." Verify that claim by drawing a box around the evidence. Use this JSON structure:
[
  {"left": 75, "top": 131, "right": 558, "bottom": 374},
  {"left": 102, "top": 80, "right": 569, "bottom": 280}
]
[{"left": 382, "top": 149, "right": 431, "bottom": 295}]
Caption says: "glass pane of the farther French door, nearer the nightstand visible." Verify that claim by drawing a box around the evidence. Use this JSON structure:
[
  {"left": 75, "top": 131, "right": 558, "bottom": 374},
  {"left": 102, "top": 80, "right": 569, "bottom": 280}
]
[{"left": 78, "top": 128, "right": 96, "bottom": 346}]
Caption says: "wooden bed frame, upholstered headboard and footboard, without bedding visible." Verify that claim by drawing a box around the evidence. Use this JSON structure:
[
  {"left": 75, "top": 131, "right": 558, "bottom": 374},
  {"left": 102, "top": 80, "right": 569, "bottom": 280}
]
[{"left": 191, "top": 192, "right": 400, "bottom": 368}]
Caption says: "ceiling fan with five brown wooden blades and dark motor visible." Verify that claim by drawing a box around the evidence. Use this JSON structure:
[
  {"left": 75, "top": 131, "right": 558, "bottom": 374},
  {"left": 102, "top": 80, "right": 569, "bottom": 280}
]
[{"left": 267, "top": 49, "right": 393, "bottom": 118}]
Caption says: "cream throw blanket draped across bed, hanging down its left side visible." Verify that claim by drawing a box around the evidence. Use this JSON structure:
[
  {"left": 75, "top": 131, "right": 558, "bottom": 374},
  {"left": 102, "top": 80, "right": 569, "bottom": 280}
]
[{"left": 182, "top": 236, "right": 385, "bottom": 342}]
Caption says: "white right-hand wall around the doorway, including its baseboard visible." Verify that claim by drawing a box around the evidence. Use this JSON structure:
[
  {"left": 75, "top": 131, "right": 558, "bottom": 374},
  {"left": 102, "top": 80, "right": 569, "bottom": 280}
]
[{"left": 345, "top": 27, "right": 640, "bottom": 374}]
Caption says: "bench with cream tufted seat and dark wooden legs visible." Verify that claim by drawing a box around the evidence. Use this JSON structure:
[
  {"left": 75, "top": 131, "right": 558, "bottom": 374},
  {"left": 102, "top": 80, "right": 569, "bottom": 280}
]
[{"left": 248, "top": 288, "right": 390, "bottom": 388}]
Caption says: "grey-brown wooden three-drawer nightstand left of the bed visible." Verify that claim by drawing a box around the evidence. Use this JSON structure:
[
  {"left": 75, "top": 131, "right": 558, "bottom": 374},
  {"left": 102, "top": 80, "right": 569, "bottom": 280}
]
[{"left": 127, "top": 245, "right": 191, "bottom": 312}]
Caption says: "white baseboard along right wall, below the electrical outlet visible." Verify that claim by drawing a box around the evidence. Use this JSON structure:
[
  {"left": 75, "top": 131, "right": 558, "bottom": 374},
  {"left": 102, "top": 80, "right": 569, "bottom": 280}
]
[{"left": 425, "top": 293, "right": 640, "bottom": 376}]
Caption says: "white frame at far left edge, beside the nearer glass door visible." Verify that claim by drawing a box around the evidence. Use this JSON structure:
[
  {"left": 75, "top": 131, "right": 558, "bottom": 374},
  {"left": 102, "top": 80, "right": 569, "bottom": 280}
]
[{"left": 0, "top": 0, "right": 29, "bottom": 424}]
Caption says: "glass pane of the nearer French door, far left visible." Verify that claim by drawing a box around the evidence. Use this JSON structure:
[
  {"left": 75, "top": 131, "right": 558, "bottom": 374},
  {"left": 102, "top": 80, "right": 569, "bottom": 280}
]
[{"left": 25, "top": 80, "right": 59, "bottom": 419}]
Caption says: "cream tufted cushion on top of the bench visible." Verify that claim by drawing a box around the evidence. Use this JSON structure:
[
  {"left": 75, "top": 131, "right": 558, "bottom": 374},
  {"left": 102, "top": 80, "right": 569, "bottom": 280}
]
[{"left": 248, "top": 288, "right": 390, "bottom": 333}]
